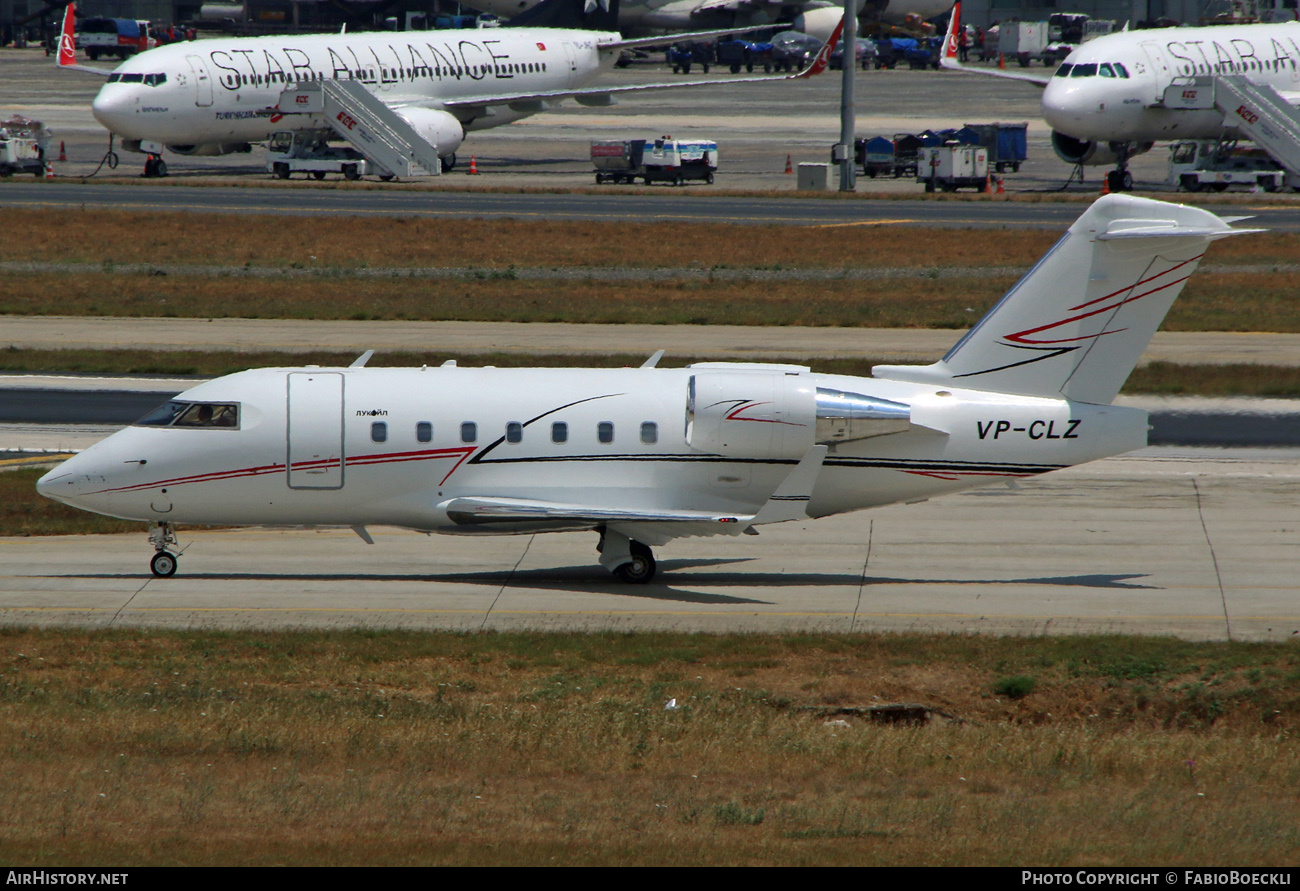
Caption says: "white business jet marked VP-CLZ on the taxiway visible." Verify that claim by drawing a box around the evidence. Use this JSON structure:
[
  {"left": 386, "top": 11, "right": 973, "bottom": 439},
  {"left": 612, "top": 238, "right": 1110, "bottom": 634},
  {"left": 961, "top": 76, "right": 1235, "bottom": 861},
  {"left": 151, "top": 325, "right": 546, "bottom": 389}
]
[{"left": 38, "top": 195, "right": 1257, "bottom": 583}]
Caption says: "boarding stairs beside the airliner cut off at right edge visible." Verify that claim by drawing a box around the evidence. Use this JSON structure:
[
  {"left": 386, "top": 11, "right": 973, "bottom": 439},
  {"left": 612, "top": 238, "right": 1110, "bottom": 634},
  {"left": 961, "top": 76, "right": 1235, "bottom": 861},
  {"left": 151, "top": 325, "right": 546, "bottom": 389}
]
[{"left": 1162, "top": 74, "right": 1300, "bottom": 176}]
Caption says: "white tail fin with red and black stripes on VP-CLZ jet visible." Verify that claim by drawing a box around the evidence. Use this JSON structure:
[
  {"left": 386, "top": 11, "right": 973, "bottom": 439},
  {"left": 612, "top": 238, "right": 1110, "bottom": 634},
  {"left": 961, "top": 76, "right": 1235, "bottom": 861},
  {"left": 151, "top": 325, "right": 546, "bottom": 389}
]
[{"left": 872, "top": 195, "right": 1261, "bottom": 405}]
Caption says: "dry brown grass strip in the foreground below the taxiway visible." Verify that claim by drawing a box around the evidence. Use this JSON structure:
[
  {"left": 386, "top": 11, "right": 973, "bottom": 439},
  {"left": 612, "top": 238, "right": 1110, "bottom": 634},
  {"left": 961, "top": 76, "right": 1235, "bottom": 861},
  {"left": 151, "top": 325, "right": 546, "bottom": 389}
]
[{"left": 0, "top": 630, "right": 1300, "bottom": 865}]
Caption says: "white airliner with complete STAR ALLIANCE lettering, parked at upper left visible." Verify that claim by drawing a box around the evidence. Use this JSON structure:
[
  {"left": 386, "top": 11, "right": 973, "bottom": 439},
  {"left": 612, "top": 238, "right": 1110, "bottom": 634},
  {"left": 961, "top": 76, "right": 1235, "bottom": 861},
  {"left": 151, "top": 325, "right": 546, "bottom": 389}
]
[{"left": 59, "top": 0, "right": 839, "bottom": 170}]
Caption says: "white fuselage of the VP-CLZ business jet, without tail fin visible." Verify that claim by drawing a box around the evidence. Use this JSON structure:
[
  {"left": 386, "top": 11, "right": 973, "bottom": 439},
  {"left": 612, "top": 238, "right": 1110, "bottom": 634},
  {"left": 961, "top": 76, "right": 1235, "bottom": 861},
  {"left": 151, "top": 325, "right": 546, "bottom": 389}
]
[{"left": 39, "top": 364, "right": 1147, "bottom": 535}]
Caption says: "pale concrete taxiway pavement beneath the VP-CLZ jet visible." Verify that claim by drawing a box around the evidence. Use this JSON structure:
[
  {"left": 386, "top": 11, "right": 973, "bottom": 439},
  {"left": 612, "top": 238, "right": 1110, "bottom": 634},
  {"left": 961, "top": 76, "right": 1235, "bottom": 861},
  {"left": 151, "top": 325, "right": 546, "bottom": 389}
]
[{"left": 0, "top": 450, "right": 1300, "bottom": 641}]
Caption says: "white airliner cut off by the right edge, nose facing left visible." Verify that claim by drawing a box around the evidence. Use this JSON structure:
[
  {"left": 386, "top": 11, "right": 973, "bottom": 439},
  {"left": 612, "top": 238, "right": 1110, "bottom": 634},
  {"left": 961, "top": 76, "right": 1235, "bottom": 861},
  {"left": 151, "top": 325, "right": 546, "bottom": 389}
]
[{"left": 941, "top": 3, "right": 1300, "bottom": 191}]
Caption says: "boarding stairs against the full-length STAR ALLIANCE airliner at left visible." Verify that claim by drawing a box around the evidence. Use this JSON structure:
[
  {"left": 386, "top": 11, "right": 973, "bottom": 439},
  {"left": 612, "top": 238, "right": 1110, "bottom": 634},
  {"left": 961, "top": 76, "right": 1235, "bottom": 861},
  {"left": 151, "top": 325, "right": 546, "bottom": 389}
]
[{"left": 277, "top": 81, "right": 442, "bottom": 178}]
